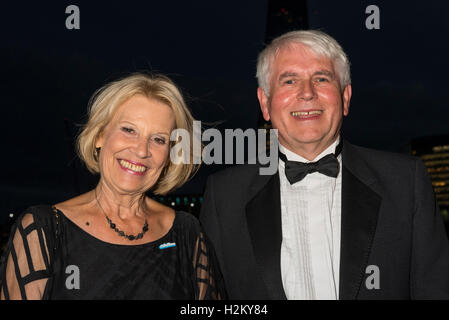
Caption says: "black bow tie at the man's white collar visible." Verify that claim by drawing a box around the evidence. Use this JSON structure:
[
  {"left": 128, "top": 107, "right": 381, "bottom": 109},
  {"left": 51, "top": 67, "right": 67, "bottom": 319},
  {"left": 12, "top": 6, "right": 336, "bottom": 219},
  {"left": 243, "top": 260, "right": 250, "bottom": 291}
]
[{"left": 279, "top": 140, "right": 343, "bottom": 184}]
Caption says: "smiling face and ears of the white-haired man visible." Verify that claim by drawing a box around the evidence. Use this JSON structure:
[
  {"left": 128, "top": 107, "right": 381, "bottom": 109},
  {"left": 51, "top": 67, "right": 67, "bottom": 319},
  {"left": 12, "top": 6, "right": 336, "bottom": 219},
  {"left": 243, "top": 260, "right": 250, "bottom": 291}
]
[{"left": 258, "top": 44, "right": 351, "bottom": 158}]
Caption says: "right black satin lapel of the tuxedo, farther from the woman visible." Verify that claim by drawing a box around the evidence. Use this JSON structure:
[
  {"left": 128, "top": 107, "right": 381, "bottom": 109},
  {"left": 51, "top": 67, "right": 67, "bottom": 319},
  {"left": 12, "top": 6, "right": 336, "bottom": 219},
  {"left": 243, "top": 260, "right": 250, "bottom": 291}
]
[{"left": 339, "top": 141, "right": 382, "bottom": 300}]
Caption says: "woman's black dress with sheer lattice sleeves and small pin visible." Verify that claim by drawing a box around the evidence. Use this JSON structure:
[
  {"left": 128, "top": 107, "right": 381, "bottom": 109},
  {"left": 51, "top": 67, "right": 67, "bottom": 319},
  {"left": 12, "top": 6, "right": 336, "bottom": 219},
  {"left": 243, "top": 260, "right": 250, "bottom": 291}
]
[{"left": 0, "top": 205, "right": 226, "bottom": 300}]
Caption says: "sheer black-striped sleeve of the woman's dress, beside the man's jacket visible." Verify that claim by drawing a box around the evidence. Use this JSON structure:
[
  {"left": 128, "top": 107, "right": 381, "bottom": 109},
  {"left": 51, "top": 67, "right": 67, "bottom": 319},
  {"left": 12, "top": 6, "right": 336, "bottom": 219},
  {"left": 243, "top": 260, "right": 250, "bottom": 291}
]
[{"left": 193, "top": 232, "right": 227, "bottom": 300}]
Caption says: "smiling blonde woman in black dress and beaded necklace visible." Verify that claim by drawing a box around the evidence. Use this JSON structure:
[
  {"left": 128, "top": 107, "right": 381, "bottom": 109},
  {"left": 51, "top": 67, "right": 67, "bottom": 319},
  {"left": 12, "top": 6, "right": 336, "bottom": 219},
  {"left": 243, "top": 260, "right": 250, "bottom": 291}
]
[{"left": 1, "top": 74, "right": 225, "bottom": 299}]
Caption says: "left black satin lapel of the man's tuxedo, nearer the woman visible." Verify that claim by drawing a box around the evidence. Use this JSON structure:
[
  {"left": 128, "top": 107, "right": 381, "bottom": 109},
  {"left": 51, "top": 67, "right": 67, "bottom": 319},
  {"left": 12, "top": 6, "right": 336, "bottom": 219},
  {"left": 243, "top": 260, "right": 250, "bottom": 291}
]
[{"left": 246, "top": 173, "right": 286, "bottom": 300}]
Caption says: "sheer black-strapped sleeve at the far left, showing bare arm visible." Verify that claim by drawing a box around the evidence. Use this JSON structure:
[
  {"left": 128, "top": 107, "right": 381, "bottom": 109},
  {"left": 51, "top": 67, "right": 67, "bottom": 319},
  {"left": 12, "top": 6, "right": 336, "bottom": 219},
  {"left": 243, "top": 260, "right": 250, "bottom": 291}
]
[{"left": 0, "top": 213, "right": 50, "bottom": 300}]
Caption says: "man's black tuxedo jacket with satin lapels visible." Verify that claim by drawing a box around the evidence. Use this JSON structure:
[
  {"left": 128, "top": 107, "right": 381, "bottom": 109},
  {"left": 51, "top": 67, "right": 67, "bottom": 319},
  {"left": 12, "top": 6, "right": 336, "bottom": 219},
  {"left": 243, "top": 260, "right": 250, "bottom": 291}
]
[{"left": 200, "top": 141, "right": 449, "bottom": 299}]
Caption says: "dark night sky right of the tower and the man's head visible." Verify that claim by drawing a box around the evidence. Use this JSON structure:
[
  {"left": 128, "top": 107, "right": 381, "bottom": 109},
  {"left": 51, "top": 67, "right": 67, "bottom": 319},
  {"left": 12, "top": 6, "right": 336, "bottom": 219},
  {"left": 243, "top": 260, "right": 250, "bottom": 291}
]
[{"left": 308, "top": 0, "right": 449, "bottom": 152}]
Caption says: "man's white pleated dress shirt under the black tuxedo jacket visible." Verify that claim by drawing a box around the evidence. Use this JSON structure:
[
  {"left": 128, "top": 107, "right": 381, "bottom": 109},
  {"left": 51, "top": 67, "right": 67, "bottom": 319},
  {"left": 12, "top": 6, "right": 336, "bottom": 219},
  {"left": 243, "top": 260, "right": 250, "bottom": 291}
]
[{"left": 279, "top": 138, "right": 341, "bottom": 300}]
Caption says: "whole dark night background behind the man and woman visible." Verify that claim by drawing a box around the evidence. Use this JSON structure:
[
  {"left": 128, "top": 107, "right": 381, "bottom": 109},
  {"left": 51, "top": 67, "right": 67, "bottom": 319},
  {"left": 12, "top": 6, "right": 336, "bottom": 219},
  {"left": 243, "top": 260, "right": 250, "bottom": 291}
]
[{"left": 0, "top": 0, "right": 449, "bottom": 223}]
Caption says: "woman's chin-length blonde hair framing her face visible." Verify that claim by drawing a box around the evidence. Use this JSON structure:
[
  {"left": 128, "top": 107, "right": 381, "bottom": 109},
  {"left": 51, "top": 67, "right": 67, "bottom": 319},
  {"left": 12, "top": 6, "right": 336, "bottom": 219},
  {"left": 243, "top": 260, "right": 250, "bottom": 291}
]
[{"left": 77, "top": 73, "right": 200, "bottom": 195}]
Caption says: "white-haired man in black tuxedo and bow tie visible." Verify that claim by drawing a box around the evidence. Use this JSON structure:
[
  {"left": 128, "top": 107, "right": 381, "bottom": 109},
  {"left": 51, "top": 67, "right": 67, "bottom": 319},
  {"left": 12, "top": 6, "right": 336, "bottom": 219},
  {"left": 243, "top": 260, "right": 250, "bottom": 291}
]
[{"left": 200, "top": 31, "right": 449, "bottom": 299}]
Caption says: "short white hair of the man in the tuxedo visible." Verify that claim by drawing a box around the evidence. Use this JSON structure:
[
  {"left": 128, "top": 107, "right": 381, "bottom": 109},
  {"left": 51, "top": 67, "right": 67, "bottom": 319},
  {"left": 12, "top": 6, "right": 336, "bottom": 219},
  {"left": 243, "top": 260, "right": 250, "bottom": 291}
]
[{"left": 256, "top": 30, "right": 351, "bottom": 96}]
